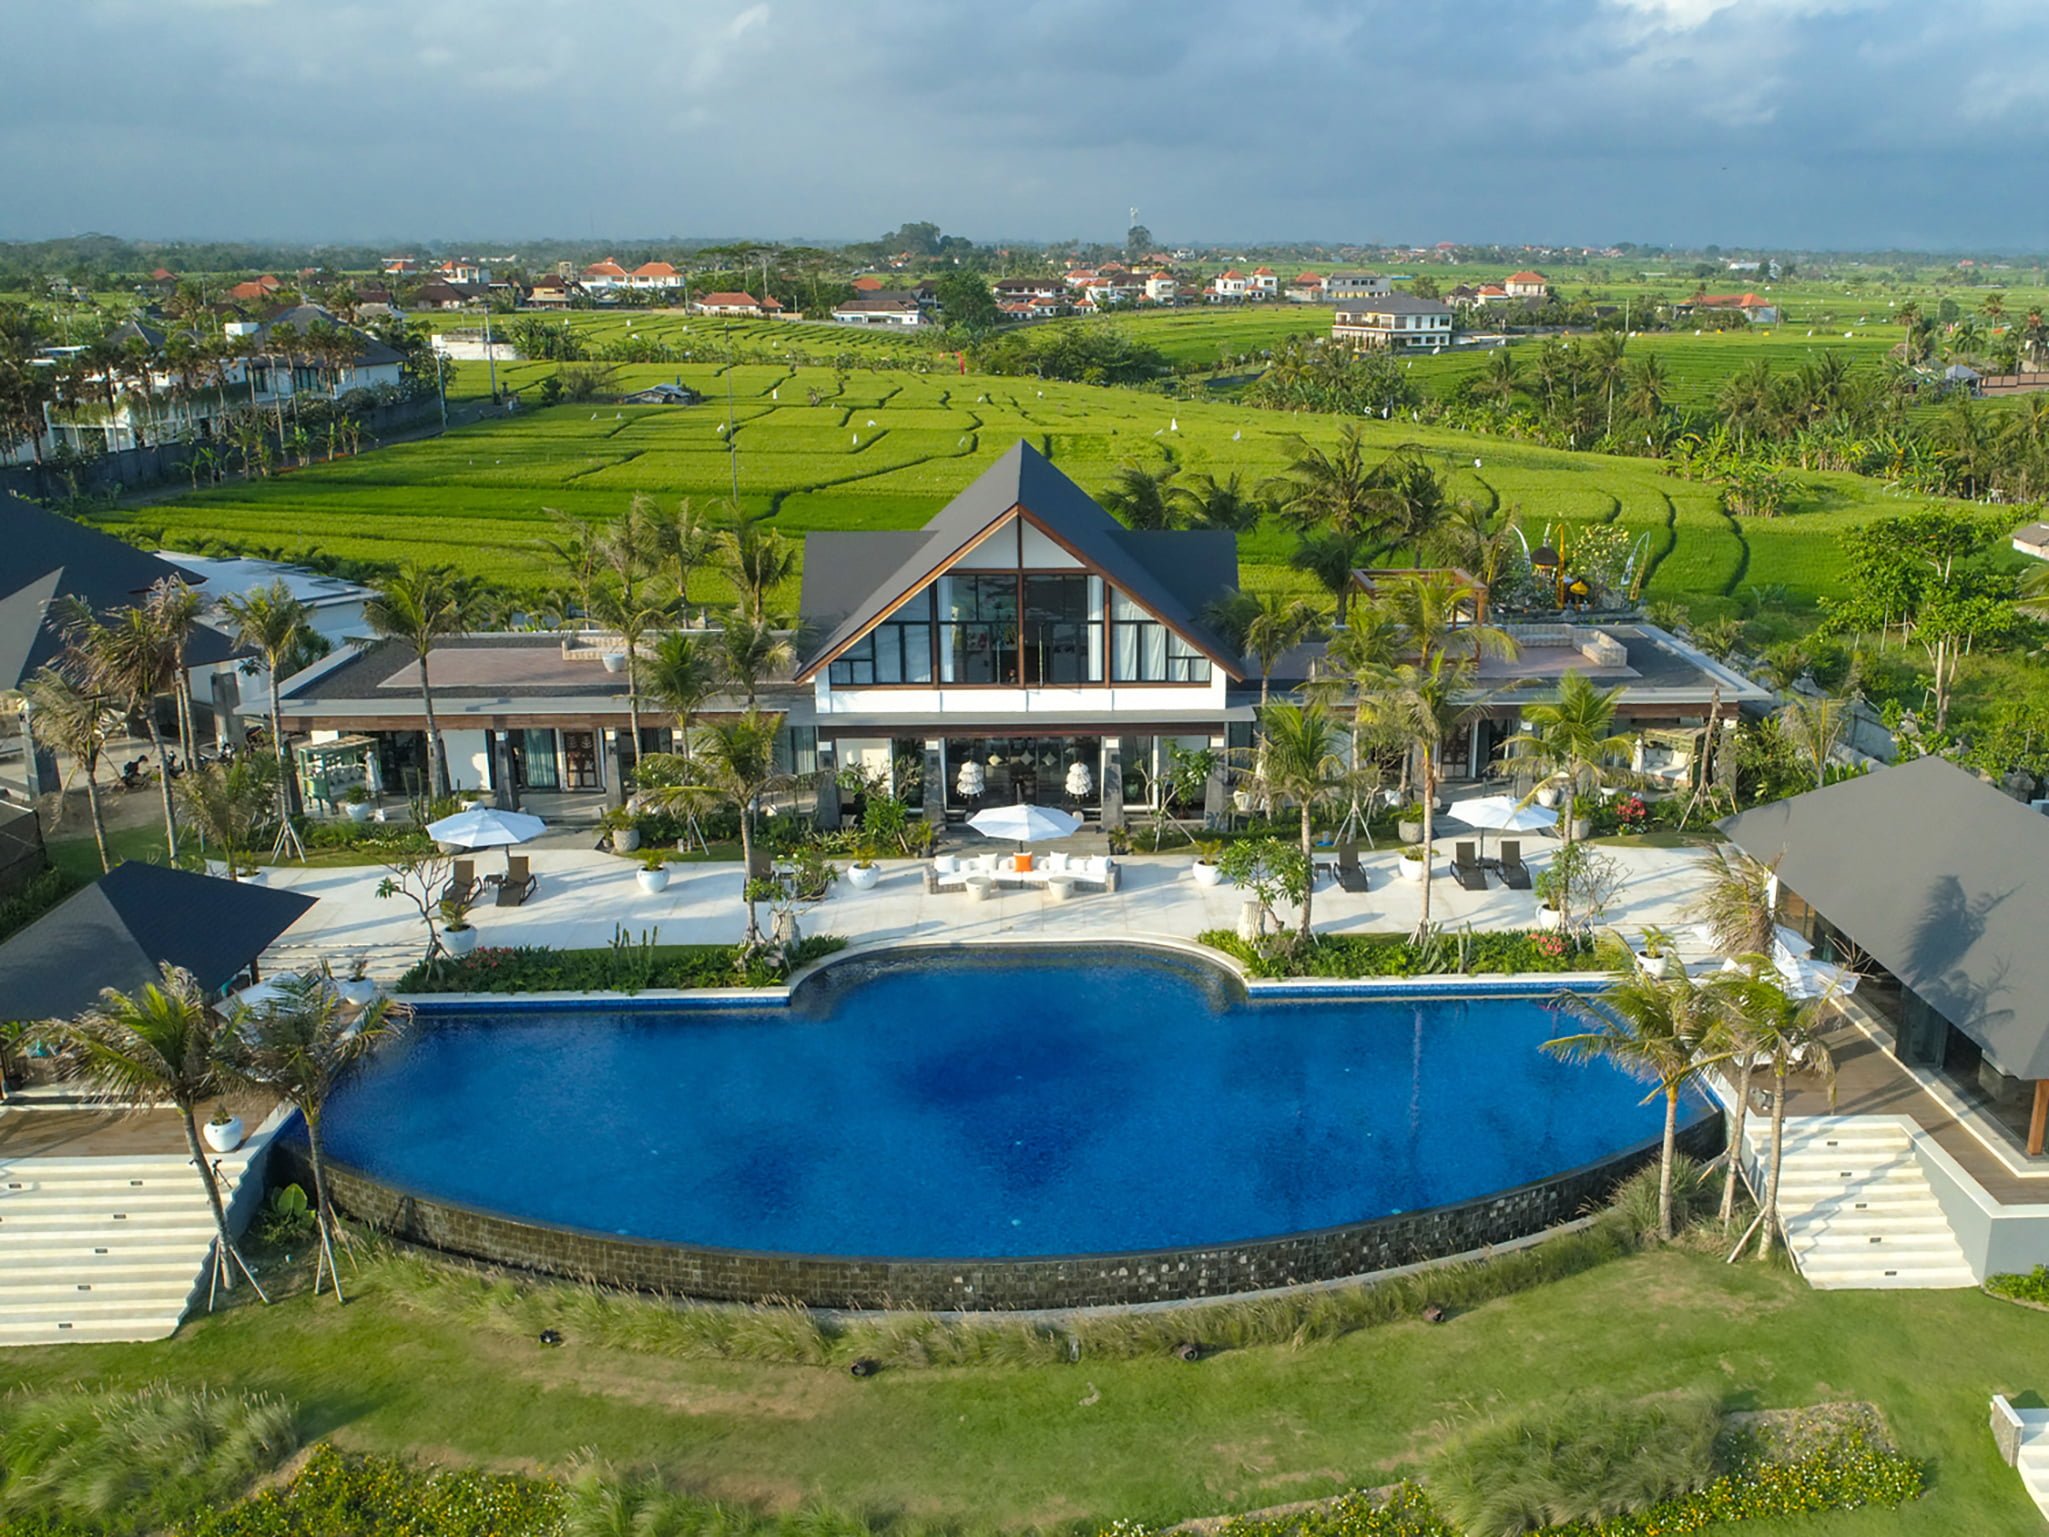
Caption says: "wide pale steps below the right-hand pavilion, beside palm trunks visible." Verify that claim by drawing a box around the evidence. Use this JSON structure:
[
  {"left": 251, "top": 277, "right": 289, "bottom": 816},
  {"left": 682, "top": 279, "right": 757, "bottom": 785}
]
[{"left": 1744, "top": 1115, "right": 1977, "bottom": 1291}]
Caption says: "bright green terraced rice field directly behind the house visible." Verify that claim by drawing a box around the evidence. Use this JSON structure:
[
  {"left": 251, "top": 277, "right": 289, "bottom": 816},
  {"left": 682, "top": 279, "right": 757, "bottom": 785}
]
[{"left": 96, "top": 363, "right": 1967, "bottom": 607}]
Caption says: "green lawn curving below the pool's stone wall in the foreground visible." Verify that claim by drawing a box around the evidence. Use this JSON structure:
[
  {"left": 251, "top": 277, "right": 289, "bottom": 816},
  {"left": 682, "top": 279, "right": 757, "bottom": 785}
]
[{"left": 0, "top": 1252, "right": 2049, "bottom": 1537}]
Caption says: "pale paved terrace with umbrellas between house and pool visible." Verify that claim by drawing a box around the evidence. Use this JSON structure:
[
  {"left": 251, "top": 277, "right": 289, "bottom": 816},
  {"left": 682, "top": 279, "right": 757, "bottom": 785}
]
[{"left": 260, "top": 838, "right": 1713, "bottom": 980}]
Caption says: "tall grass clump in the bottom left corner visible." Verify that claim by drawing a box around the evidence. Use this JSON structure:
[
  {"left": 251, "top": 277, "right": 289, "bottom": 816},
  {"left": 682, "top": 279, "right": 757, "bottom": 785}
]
[{"left": 0, "top": 1383, "right": 299, "bottom": 1533}]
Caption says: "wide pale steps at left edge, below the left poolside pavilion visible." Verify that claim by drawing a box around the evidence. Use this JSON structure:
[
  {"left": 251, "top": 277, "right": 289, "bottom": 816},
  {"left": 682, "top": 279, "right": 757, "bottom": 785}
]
[{"left": 0, "top": 1146, "right": 254, "bottom": 1344}]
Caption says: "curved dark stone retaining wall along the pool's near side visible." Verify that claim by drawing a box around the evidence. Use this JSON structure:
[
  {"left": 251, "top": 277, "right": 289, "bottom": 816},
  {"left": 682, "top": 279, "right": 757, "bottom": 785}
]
[{"left": 297, "top": 1115, "right": 1725, "bottom": 1312}]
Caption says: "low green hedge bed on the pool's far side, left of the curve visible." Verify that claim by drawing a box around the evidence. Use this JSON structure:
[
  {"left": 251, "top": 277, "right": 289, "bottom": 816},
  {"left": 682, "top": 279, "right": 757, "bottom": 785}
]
[{"left": 398, "top": 934, "right": 846, "bottom": 992}]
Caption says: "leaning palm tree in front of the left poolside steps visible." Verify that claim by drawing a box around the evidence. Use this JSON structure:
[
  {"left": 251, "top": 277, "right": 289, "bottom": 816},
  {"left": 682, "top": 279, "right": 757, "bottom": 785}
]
[{"left": 51, "top": 961, "right": 270, "bottom": 1301}]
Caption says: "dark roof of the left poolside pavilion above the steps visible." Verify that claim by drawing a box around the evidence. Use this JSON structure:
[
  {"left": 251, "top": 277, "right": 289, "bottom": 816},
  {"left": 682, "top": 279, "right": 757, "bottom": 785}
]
[{"left": 0, "top": 859, "right": 313, "bottom": 1019}]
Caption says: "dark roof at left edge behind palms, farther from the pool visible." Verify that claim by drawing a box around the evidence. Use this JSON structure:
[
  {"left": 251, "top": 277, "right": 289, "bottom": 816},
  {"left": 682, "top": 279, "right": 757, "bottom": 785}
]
[{"left": 0, "top": 492, "right": 236, "bottom": 689}]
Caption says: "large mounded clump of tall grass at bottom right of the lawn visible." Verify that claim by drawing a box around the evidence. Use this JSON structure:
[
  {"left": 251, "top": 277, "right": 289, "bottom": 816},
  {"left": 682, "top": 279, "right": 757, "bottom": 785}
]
[{"left": 1430, "top": 1394, "right": 1721, "bottom": 1537}]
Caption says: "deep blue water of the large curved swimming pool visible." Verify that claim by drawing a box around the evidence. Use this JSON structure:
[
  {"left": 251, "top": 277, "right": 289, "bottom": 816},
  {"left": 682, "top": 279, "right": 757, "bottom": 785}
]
[{"left": 326, "top": 949, "right": 1701, "bottom": 1258}]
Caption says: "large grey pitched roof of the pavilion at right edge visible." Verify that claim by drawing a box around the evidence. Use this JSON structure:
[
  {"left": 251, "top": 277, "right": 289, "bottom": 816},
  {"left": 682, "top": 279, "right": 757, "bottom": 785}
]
[{"left": 1721, "top": 758, "right": 2049, "bottom": 1078}]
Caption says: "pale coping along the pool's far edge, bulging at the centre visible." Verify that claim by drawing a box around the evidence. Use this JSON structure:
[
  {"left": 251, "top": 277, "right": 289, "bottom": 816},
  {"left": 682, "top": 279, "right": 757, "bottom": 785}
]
[{"left": 391, "top": 934, "right": 1615, "bottom": 1012}]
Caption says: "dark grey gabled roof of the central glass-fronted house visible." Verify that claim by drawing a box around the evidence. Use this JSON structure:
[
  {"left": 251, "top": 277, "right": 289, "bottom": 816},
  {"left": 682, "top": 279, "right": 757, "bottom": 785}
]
[{"left": 797, "top": 441, "right": 1244, "bottom": 682}]
